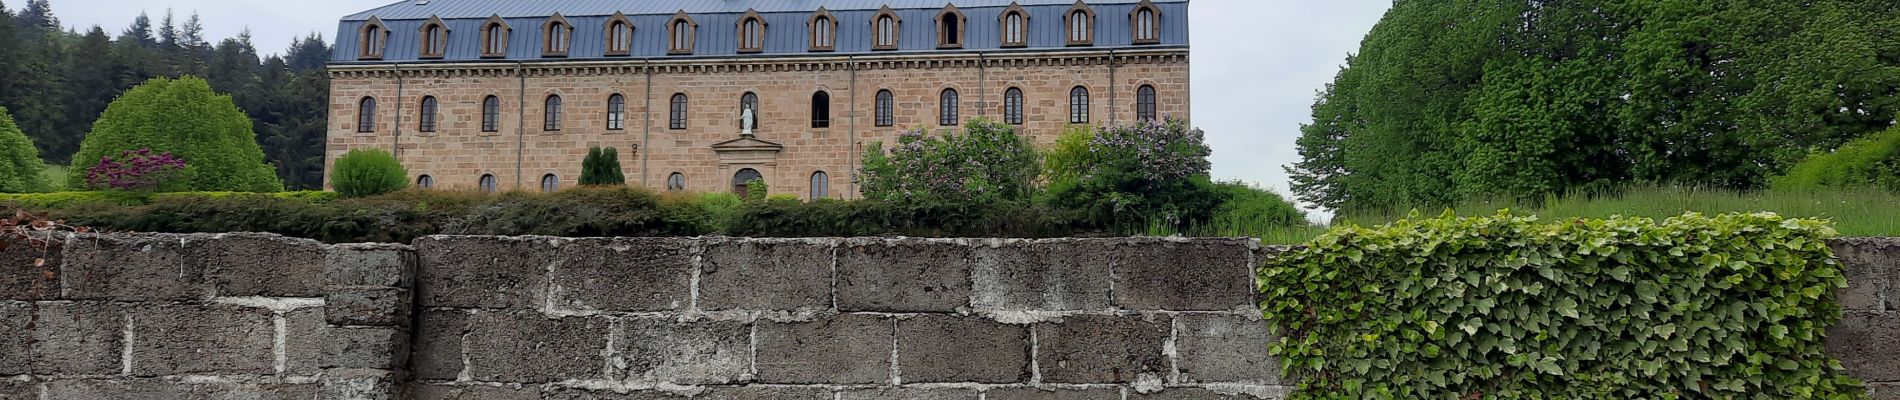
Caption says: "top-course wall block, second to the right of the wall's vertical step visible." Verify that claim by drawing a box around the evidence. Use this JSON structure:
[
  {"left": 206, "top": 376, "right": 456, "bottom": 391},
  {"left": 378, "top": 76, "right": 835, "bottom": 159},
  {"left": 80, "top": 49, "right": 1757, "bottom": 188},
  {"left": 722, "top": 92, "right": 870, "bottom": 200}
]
[{"left": 547, "top": 239, "right": 694, "bottom": 311}]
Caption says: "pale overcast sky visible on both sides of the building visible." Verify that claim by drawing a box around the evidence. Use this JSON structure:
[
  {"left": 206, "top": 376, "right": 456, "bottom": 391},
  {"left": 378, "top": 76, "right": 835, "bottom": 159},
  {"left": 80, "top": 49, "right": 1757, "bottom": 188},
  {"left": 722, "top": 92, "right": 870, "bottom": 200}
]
[{"left": 40, "top": 0, "right": 1393, "bottom": 218}]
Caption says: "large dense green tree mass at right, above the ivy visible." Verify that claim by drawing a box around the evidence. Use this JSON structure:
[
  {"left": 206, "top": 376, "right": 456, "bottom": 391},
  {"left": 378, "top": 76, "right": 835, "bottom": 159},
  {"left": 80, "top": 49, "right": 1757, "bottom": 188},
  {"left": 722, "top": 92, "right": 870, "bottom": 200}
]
[{"left": 1290, "top": 0, "right": 1900, "bottom": 210}]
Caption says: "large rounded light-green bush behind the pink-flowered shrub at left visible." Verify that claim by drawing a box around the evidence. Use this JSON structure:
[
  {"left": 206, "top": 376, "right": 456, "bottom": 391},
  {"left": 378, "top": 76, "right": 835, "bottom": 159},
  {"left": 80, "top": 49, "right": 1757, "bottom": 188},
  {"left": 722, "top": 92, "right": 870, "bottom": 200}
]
[{"left": 68, "top": 78, "right": 283, "bottom": 193}]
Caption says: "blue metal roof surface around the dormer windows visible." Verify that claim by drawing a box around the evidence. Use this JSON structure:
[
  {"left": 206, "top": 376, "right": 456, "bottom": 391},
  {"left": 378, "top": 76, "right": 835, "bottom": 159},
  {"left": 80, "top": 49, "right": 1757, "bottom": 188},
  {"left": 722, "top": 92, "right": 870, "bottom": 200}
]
[{"left": 331, "top": 0, "right": 1188, "bottom": 64}]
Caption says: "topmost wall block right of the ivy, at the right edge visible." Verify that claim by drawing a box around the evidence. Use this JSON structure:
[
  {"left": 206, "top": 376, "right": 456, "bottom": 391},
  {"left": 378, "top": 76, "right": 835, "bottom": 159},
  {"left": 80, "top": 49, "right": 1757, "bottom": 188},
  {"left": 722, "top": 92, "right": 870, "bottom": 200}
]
[{"left": 1828, "top": 237, "right": 1900, "bottom": 311}]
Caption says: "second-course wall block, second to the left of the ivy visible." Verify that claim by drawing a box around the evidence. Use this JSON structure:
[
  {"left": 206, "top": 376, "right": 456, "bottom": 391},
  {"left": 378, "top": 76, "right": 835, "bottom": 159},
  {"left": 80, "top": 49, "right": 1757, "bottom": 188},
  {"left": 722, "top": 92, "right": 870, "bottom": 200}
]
[{"left": 1036, "top": 315, "right": 1172, "bottom": 383}]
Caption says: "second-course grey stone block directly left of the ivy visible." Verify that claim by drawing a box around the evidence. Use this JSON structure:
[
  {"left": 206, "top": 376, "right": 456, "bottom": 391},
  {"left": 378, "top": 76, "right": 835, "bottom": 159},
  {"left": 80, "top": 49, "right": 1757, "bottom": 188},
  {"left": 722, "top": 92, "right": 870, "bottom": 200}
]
[{"left": 1174, "top": 315, "right": 1281, "bottom": 385}]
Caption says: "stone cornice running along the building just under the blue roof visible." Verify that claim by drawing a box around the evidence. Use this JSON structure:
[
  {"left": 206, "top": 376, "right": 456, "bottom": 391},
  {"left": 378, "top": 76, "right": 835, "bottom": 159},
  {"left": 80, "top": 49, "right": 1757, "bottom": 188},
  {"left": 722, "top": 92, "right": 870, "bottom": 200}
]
[{"left": 329, "top": 47, "right": 1188, "bottom": 78}]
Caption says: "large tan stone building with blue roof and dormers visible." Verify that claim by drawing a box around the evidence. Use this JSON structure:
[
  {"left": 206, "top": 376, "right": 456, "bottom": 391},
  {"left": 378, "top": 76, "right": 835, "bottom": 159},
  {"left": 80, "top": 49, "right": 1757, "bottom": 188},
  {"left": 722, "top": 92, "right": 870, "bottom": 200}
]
[{"left": 325, "top": 0, "right": 1189, "bottom": 199}]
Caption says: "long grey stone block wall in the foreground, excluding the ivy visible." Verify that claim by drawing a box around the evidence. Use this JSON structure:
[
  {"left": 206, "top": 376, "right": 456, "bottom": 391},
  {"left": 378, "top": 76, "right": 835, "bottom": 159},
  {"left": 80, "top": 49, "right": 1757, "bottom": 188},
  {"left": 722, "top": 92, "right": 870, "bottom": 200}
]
[{"left": 0, "top": 233, "right": 1900, "bottom": 400}]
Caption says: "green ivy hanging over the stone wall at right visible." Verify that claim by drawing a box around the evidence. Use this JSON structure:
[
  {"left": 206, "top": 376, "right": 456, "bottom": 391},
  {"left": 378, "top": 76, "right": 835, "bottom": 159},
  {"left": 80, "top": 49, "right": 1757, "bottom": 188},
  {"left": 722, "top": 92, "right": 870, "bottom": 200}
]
[{"left": 1256, "top": 212, "right": 1864, "bottom": 398}]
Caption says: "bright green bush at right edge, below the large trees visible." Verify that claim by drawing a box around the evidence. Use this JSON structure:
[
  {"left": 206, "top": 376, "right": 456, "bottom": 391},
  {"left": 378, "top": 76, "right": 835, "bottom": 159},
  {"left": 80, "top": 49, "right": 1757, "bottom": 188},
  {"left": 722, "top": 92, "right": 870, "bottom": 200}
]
[{"left": 1775, "top": 127, "right": 1900, "bottom": 191}]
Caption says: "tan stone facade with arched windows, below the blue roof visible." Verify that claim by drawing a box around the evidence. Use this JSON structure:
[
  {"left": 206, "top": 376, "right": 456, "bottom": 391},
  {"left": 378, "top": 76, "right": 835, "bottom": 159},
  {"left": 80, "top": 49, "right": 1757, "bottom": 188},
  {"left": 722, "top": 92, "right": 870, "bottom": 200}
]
[{"left": 325, "top": 47, "right": 1189, "bottom": 199}]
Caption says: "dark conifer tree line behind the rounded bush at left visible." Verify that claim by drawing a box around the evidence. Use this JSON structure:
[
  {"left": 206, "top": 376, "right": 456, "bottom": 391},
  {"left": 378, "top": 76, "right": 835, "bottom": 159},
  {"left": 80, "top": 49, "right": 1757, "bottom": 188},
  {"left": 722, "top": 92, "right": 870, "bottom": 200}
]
[{"left": 0, "top": 0, "right": 329, "bottom": 190}]
